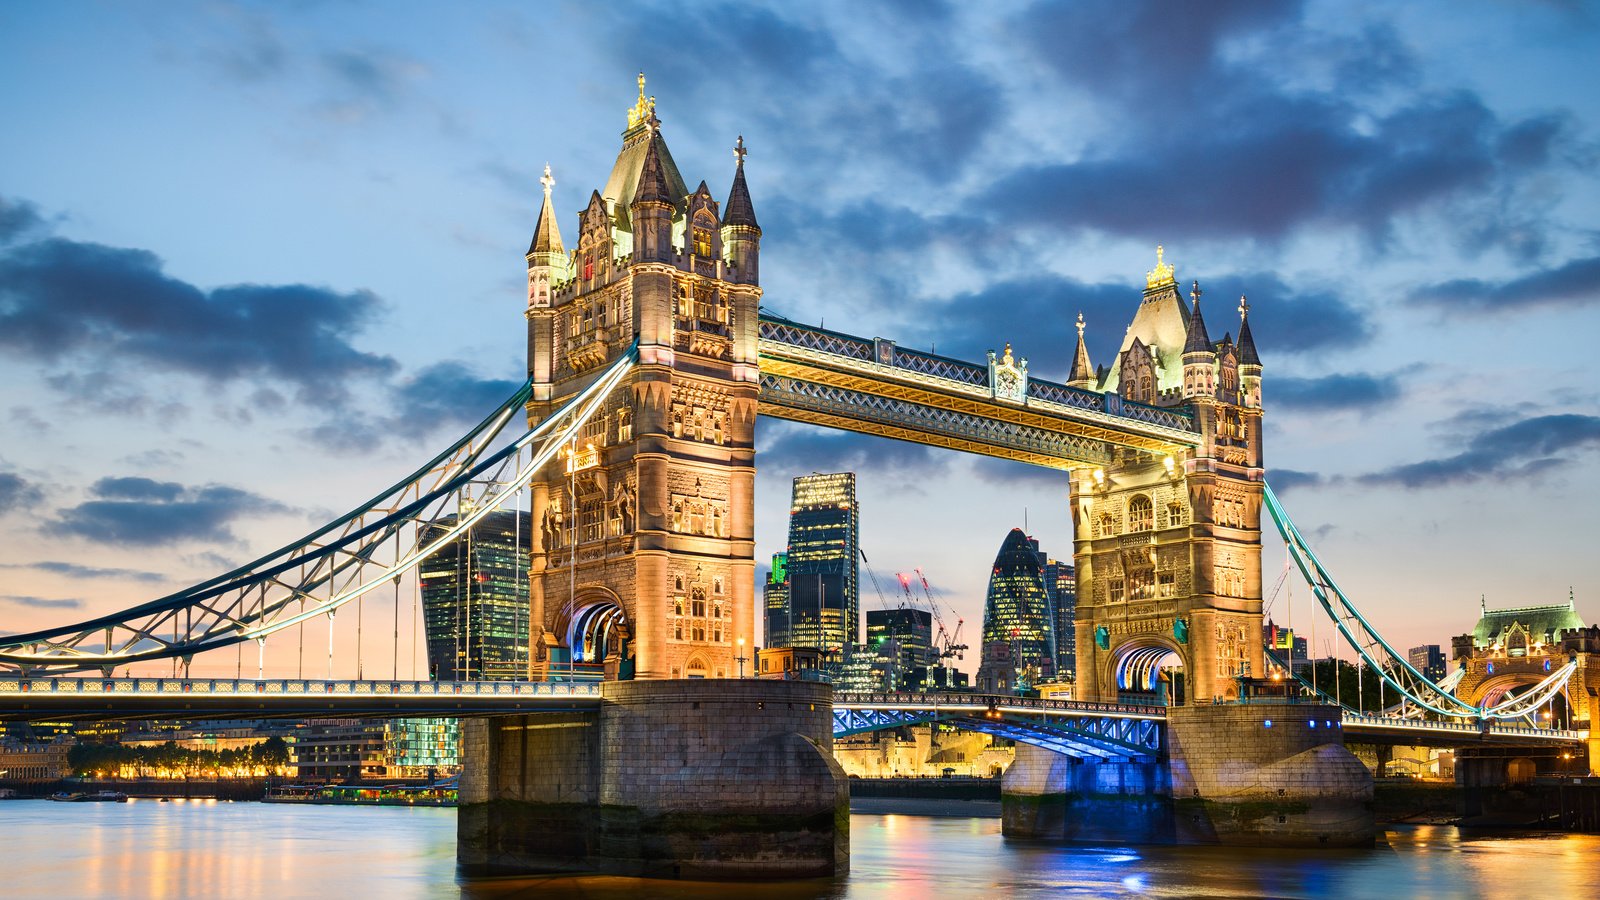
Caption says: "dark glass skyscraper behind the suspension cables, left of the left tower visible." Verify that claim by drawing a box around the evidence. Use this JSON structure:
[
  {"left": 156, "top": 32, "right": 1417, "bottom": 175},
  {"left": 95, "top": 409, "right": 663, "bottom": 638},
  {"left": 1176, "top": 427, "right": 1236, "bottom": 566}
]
[{"left": 421, "top": 511, "right": 531, "bottom": 681}]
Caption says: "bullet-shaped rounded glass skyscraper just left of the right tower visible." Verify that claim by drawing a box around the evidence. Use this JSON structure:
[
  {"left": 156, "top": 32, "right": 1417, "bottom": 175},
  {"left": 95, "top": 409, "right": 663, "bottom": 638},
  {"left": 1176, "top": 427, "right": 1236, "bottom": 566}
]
[{"left": 978, "top": 528, "right": 1054, "bottom": 690}]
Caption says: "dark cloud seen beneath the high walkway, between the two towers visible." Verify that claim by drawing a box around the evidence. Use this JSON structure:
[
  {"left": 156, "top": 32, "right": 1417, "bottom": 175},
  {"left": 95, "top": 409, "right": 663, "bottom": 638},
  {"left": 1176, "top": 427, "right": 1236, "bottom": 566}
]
[{"left": 755, "top": 420, "right": 949, "bottom": 479}]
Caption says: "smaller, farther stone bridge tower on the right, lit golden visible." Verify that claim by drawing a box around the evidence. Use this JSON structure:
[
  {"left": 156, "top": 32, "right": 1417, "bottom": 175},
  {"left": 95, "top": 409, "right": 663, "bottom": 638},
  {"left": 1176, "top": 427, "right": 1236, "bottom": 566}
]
[{"left": 1072, "top": 248, "right": 1264, "bottom": 703}]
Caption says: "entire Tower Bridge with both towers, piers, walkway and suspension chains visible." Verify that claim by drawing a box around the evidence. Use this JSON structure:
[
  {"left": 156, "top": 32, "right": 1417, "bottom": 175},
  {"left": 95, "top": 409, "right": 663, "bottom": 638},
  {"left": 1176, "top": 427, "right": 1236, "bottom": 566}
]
[{"left": 0, "top": 77, "right": 1594, "bottom": 876}]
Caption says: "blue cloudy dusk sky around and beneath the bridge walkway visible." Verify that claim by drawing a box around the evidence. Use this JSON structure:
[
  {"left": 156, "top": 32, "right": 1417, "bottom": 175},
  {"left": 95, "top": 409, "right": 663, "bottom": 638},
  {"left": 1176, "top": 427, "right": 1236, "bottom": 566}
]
[{"left": 0, "top": 0, "right": 1600, "bottom": 674}]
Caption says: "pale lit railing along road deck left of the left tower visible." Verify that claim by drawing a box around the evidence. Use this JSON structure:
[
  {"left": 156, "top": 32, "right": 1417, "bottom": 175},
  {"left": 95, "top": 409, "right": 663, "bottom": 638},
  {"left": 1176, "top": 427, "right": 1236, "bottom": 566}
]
[{"left": 0, "top": 677, "right": 600, "bottom": 698}]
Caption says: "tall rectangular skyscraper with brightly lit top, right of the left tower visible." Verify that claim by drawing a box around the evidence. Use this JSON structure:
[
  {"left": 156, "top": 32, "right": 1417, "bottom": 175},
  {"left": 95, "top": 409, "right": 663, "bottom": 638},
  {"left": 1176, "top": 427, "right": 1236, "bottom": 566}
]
[{"left": 789, "top": 472, "right": 861, "bottom": 653}]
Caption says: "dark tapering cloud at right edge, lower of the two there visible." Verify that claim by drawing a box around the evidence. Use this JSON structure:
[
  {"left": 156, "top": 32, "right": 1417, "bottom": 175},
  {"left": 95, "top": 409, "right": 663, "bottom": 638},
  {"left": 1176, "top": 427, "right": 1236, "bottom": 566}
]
[{"left": 1358, "top": 413, "right": 1600, "bottom": 488}]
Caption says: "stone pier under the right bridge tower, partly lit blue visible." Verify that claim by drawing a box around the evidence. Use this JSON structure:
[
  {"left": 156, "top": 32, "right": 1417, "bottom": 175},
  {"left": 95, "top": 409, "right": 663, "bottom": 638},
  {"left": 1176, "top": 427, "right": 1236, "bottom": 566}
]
[{"left": 1000, "top": 703, "right": 1376, "bottom": 847}]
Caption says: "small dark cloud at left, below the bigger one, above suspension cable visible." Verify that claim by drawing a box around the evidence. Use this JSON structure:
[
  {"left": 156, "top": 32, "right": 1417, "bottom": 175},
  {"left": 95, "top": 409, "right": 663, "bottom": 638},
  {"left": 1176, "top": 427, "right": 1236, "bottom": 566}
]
[{"left": 45, "top": 477, "right": 290, "bottom": 546}]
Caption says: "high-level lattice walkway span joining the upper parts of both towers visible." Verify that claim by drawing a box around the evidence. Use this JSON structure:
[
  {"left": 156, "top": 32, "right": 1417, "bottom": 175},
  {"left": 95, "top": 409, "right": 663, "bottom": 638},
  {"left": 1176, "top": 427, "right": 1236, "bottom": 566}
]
[{"left": 758, "top": 314, "right": 1200, "bottom": 469}]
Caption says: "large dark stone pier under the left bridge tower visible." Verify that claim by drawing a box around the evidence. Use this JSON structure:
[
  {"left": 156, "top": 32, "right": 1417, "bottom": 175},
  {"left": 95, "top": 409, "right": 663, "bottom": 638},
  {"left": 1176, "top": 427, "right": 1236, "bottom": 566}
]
[{"left": 456, "top": 679, "right": 850, "bottom": 879}]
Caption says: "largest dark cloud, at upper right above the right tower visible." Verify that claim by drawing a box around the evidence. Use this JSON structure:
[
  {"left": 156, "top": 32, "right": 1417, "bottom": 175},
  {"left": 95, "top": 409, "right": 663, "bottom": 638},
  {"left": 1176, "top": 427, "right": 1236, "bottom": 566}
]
[{"left": 984, "top": 2, "right": 1570, "bottom": 253}]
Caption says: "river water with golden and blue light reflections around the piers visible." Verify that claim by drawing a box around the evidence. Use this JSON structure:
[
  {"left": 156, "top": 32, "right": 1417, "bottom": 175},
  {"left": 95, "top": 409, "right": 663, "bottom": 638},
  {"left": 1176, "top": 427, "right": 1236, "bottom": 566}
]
[{"left": 0, "top": 801, "right": 1600, "bottom": 900}]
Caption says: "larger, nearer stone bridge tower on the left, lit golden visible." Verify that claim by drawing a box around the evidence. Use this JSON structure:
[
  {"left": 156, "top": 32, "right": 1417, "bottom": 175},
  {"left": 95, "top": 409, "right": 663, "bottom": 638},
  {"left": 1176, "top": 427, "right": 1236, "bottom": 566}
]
[{"left": 526, "top": 75, "right": 762, "bottom": 679}]
